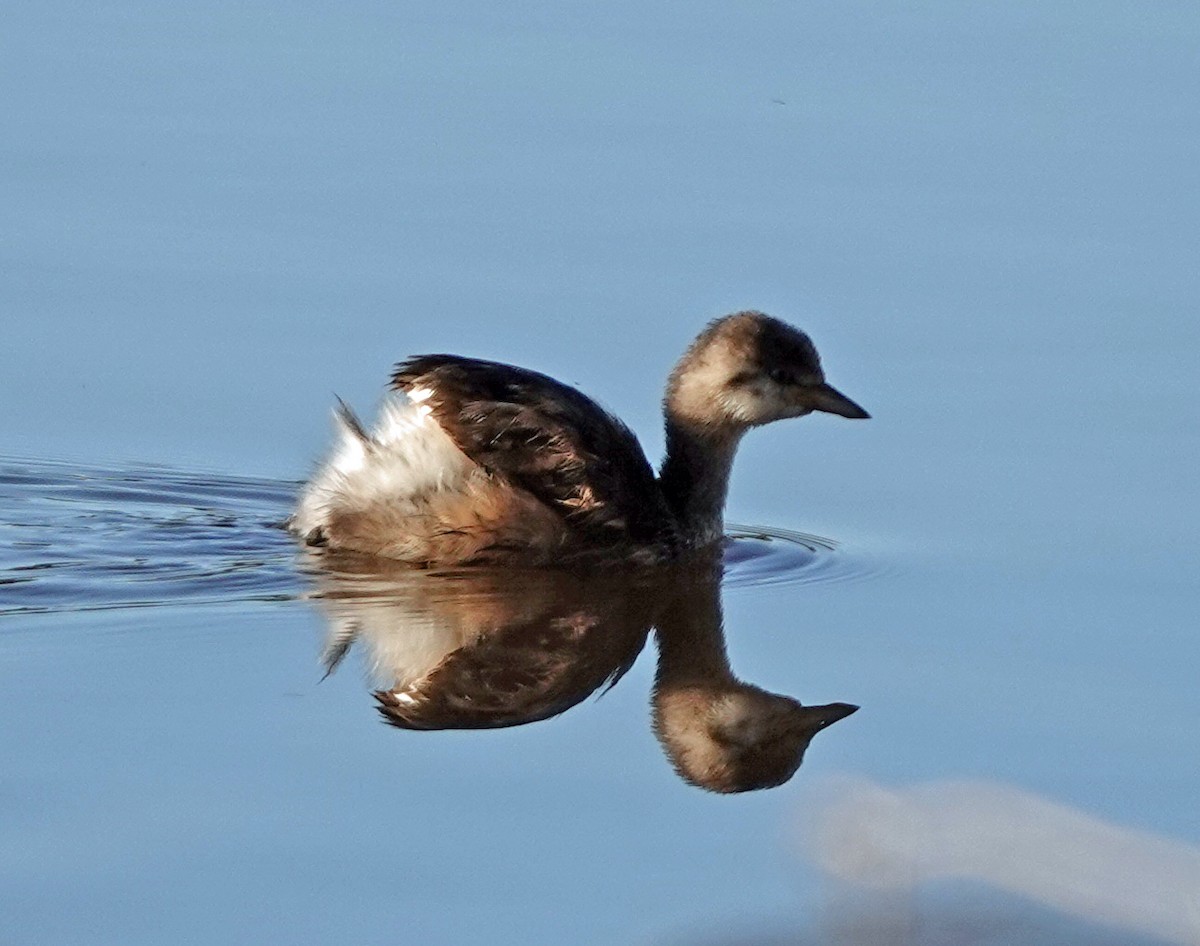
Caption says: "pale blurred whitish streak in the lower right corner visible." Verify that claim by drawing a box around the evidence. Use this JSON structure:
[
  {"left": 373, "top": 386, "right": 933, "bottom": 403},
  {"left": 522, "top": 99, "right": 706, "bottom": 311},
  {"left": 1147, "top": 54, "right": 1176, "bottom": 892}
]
[{"left": 811, "top": 782, "right": 1200, "bottom": 946}]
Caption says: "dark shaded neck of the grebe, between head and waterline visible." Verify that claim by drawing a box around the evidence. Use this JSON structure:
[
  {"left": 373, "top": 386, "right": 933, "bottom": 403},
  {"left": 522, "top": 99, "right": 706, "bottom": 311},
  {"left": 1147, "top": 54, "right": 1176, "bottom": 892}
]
[{"left": 659, "top": 413, "right": 742, "bottom": 546}]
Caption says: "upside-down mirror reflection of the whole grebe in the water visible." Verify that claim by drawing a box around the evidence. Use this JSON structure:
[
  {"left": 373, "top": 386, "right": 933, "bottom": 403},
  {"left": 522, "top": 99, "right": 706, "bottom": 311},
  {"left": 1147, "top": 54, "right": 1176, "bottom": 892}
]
[{"left": 310, "top": 552, "right": 858, "bottom": 792}]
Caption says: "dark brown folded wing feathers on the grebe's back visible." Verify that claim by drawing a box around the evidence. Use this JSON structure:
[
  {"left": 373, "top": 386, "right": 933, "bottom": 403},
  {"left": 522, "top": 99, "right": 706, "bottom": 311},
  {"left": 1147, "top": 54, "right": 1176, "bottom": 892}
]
[{"left": 392, "top": 354, "right": 673, "bottom": 545}]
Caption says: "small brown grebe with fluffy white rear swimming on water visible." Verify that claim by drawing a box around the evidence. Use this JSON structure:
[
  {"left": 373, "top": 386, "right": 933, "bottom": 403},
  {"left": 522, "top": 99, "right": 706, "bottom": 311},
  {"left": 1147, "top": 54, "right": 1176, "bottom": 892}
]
[{"left": 289, "top": 312, "right": 870, "bottom": 565}]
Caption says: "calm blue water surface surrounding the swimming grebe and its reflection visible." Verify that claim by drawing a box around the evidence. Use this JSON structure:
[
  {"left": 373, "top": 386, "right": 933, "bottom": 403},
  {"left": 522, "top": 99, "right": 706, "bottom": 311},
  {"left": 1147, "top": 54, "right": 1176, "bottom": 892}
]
[{"left": 0, "top": 2, "right": 1200, "bottom": 944}]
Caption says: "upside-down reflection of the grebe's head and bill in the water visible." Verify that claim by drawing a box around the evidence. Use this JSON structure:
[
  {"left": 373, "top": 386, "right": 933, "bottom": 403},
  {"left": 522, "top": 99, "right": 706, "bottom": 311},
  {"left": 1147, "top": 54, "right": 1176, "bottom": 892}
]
[{"left": 654, "top": 683, "right": 858, "bottom": 792}]
